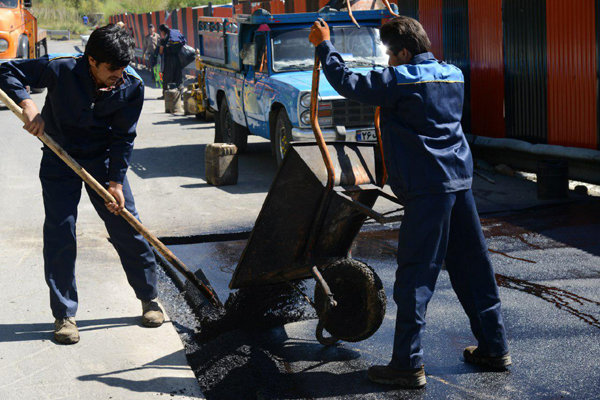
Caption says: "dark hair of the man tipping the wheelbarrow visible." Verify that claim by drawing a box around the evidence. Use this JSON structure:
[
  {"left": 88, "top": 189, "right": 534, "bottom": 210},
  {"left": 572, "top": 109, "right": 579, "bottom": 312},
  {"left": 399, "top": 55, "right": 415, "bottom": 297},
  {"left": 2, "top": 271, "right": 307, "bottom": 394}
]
[{"left": 380, "top": 15, "right": 431, "bottom": 56}]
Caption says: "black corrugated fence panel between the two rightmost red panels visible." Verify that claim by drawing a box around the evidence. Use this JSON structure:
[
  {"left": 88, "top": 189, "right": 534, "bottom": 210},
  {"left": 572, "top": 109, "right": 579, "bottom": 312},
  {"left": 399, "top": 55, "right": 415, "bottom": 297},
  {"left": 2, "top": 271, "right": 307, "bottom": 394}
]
[{"left": 503, "top": 0, "right": 548, "bottom": 143}]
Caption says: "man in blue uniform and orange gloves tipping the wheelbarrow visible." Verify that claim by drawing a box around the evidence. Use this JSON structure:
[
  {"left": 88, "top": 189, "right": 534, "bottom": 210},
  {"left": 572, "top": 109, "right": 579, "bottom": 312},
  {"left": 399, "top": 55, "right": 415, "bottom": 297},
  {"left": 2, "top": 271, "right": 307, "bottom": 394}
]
[{"left": 309, "top": 16, "right": 511, "bottom": 388}]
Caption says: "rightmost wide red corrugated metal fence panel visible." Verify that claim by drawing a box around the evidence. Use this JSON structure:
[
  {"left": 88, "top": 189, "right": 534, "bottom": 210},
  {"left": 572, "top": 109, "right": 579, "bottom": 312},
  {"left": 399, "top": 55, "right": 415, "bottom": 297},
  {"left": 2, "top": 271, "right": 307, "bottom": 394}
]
[{"left": 546, "top": 0, "right": 598, "bottom": 149}]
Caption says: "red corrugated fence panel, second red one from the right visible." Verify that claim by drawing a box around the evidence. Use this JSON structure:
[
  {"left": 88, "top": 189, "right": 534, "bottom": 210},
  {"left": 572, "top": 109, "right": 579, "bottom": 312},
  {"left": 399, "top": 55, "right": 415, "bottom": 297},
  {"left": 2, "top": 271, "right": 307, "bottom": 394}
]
[{"left": 469, "top": 0, "right": 506, "bottom": 138}]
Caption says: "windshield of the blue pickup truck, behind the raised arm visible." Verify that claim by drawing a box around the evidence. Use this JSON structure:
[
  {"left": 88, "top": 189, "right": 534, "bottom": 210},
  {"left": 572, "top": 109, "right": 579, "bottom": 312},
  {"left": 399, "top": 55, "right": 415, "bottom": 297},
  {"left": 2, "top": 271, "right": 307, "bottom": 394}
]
[{"left": 272, "top": 26, "right": 388, "bottom": 72}]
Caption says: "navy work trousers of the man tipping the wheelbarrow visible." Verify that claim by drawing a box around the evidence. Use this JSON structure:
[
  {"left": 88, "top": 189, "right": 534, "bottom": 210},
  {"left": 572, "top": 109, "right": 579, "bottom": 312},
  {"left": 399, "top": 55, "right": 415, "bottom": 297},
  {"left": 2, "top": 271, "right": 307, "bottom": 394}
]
[{"left": 390, "top": 189, "right": 508, "bottom": 369}]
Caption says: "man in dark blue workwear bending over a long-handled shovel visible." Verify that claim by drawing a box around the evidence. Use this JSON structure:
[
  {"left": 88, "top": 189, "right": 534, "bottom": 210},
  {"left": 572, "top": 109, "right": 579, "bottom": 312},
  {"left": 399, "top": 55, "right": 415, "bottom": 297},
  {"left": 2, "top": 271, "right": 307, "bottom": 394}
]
[{"left": 0, "top": 25, "right": 164, "bottom": 344}]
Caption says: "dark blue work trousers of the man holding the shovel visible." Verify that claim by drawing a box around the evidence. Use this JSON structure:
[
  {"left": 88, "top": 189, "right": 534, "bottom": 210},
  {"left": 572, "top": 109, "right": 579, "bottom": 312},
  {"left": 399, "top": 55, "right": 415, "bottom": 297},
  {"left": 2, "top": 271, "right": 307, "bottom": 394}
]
[{"left": 40, "top": 150, "right": 157, "bottom": 318}]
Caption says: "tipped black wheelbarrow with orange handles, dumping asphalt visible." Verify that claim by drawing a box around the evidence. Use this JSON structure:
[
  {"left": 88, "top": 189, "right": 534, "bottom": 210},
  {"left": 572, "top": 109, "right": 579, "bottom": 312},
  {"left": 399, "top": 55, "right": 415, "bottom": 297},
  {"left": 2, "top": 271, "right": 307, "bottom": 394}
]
[{"left": 229, "top": 18, "right": 401, "bottom": 345}]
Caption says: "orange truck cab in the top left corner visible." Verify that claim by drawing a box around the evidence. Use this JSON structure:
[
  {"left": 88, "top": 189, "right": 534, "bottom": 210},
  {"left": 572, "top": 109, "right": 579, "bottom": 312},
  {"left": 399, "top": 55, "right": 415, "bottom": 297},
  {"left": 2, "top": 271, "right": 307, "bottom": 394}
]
[{"left": 0, "top": 0, "right": 47, "bottom": 62}]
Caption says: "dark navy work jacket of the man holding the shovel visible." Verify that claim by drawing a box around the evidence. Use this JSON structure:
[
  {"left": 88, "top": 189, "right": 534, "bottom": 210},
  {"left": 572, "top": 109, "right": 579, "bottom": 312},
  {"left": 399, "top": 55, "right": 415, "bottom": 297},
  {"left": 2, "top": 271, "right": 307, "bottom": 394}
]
[{"left": 0, "top": 54, "right": 144, "bottom": 183}]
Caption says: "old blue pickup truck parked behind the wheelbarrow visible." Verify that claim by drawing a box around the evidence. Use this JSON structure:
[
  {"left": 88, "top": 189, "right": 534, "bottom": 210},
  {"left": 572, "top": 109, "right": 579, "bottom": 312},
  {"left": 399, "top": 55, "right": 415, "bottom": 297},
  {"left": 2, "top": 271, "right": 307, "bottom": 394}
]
[{"left": 198, "top": 10, "right": 391, "bottom": 163}]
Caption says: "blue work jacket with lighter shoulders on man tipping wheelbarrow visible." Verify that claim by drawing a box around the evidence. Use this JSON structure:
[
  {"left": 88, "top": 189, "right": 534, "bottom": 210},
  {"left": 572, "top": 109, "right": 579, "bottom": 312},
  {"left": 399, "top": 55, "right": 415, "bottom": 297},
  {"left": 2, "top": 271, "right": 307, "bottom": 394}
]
[{"left": 317, "top": 40, "right": 473, "bottom": 198}]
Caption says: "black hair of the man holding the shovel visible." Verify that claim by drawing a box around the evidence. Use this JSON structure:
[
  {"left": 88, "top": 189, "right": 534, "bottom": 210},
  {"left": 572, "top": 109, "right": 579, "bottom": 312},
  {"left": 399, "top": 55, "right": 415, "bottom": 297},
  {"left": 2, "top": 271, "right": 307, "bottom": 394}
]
[{"left": 85, "top": 24, "right": 134, "bottom": 68}]
